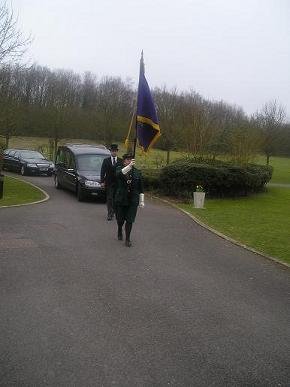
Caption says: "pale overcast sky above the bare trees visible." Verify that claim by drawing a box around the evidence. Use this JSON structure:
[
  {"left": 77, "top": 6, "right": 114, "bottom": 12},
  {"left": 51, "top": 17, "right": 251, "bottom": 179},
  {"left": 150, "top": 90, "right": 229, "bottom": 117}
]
[{"left": 11, "top": 0, "right": 290, "bottom": 120}]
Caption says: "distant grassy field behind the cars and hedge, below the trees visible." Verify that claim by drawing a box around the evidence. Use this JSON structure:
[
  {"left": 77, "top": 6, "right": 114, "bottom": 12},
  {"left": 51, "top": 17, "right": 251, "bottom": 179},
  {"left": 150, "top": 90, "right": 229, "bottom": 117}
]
[{"left": 5, "top": 137, "right": 290, "bottom": 184}]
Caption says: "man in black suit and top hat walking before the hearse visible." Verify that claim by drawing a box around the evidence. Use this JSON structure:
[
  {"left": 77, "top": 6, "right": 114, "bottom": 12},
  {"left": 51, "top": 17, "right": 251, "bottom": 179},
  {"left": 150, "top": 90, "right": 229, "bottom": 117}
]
[{"left": 101, "top": 144, "right": 122, "bottom": 220}]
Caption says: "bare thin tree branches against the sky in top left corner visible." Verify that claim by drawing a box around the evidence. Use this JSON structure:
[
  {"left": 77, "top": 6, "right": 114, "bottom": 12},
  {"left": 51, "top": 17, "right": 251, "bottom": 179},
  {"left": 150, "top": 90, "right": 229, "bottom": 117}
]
[{"left": 0, "top": 1, "right": 31, "bottom": 63}]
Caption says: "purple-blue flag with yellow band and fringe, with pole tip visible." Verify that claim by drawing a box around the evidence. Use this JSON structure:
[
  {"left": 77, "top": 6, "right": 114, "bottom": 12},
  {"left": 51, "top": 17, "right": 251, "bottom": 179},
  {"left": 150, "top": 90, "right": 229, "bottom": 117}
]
[{"left": 136, "top": 51, "right": 160, "bottom": 152}]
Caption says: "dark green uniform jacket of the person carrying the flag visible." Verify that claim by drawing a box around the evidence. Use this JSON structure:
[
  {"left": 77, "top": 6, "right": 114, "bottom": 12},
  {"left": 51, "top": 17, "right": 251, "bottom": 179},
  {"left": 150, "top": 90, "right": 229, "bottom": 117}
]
[{"left": 115, "top": 166, "right": 143, "bottom": 207}]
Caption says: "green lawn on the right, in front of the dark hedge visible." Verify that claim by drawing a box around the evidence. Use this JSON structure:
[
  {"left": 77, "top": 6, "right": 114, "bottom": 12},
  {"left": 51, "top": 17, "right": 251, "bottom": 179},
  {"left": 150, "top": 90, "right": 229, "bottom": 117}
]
[{"left": 179, "top": 187, "right": 290, "bottom": 263}]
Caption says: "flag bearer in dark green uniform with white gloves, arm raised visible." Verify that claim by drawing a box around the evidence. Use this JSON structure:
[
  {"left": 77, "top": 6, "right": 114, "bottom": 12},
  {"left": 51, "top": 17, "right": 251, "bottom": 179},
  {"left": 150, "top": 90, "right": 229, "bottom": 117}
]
[{"left": 115, "top": 153, "right": 144, "bottom": 247}]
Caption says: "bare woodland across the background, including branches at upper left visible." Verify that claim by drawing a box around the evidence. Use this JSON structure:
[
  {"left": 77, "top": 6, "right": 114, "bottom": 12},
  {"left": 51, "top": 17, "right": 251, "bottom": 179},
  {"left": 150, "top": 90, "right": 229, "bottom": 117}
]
[{"left": 0, "top": 1, "right": 290, "bottom": 163}]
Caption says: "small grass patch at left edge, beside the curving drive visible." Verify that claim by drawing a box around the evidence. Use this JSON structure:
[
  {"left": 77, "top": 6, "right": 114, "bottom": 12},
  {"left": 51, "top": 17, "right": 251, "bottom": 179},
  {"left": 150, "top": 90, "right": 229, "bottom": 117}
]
[{"left": 0, "top": 176, "right": 45, "bottom": 207}]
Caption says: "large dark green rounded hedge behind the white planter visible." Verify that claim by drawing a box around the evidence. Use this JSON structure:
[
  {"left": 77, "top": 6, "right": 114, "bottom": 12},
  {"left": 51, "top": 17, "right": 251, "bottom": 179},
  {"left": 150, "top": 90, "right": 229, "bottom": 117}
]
[{"left": 160, "top": 158, "right": 273, "bottom": 198}]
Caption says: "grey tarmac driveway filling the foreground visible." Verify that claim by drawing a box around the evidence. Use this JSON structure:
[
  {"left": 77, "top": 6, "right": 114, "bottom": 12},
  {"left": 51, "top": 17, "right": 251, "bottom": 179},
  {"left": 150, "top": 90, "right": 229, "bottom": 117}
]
[{"left": 0, "top": 177, "right": 290, "bottom": 387}]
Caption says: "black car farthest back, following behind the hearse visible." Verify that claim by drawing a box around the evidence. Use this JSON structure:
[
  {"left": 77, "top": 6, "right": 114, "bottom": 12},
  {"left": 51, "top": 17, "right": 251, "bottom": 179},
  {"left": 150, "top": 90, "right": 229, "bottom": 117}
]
[{"left": 3, "top": 149, "right": 54, "bottom": 176}]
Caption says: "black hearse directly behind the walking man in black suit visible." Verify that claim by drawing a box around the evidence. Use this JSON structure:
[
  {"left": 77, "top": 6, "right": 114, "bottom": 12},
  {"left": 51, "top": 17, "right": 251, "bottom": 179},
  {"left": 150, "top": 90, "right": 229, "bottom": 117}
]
[{"left": 54, "top": 144, "right": 110, "bottom": 201}]
